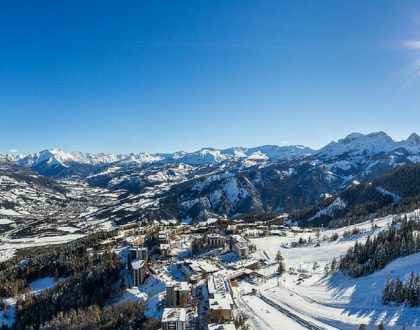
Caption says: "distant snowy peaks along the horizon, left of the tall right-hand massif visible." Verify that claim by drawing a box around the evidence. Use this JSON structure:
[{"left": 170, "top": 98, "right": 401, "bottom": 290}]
[{"left": 16, "top": 146, "right": 313, "bottom": 178}]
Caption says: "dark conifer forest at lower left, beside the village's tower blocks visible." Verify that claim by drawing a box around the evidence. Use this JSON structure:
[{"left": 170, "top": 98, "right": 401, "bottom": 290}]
[{"left": 0, "top": 231, "right": 160, "bottom": 330}]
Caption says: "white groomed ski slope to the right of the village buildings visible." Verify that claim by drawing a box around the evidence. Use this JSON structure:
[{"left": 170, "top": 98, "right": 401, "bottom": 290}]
[{"left": 240, "top": 210, "right": 420, "bottom": 329}]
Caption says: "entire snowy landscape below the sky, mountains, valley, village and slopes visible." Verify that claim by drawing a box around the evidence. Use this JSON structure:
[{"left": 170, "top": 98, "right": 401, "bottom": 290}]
[{"left": 0, "top": 132, "right": 420, "bottom": 330}]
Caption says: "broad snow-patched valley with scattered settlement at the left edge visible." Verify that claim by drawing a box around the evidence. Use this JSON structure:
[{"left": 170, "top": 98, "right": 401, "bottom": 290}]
[{"left": 0, "top": 156, "right": 118, "bottom": 254}]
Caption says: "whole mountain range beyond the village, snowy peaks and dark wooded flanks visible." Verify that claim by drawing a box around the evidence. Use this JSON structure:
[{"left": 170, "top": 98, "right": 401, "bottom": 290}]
[{"left": 0, "top": 132, "right": 420, "bottom": 223}]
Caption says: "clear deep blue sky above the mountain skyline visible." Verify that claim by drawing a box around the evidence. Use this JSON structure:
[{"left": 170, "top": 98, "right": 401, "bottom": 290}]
[{"left": 0, "top": 0, "right": 420, "bottom": 153}]
